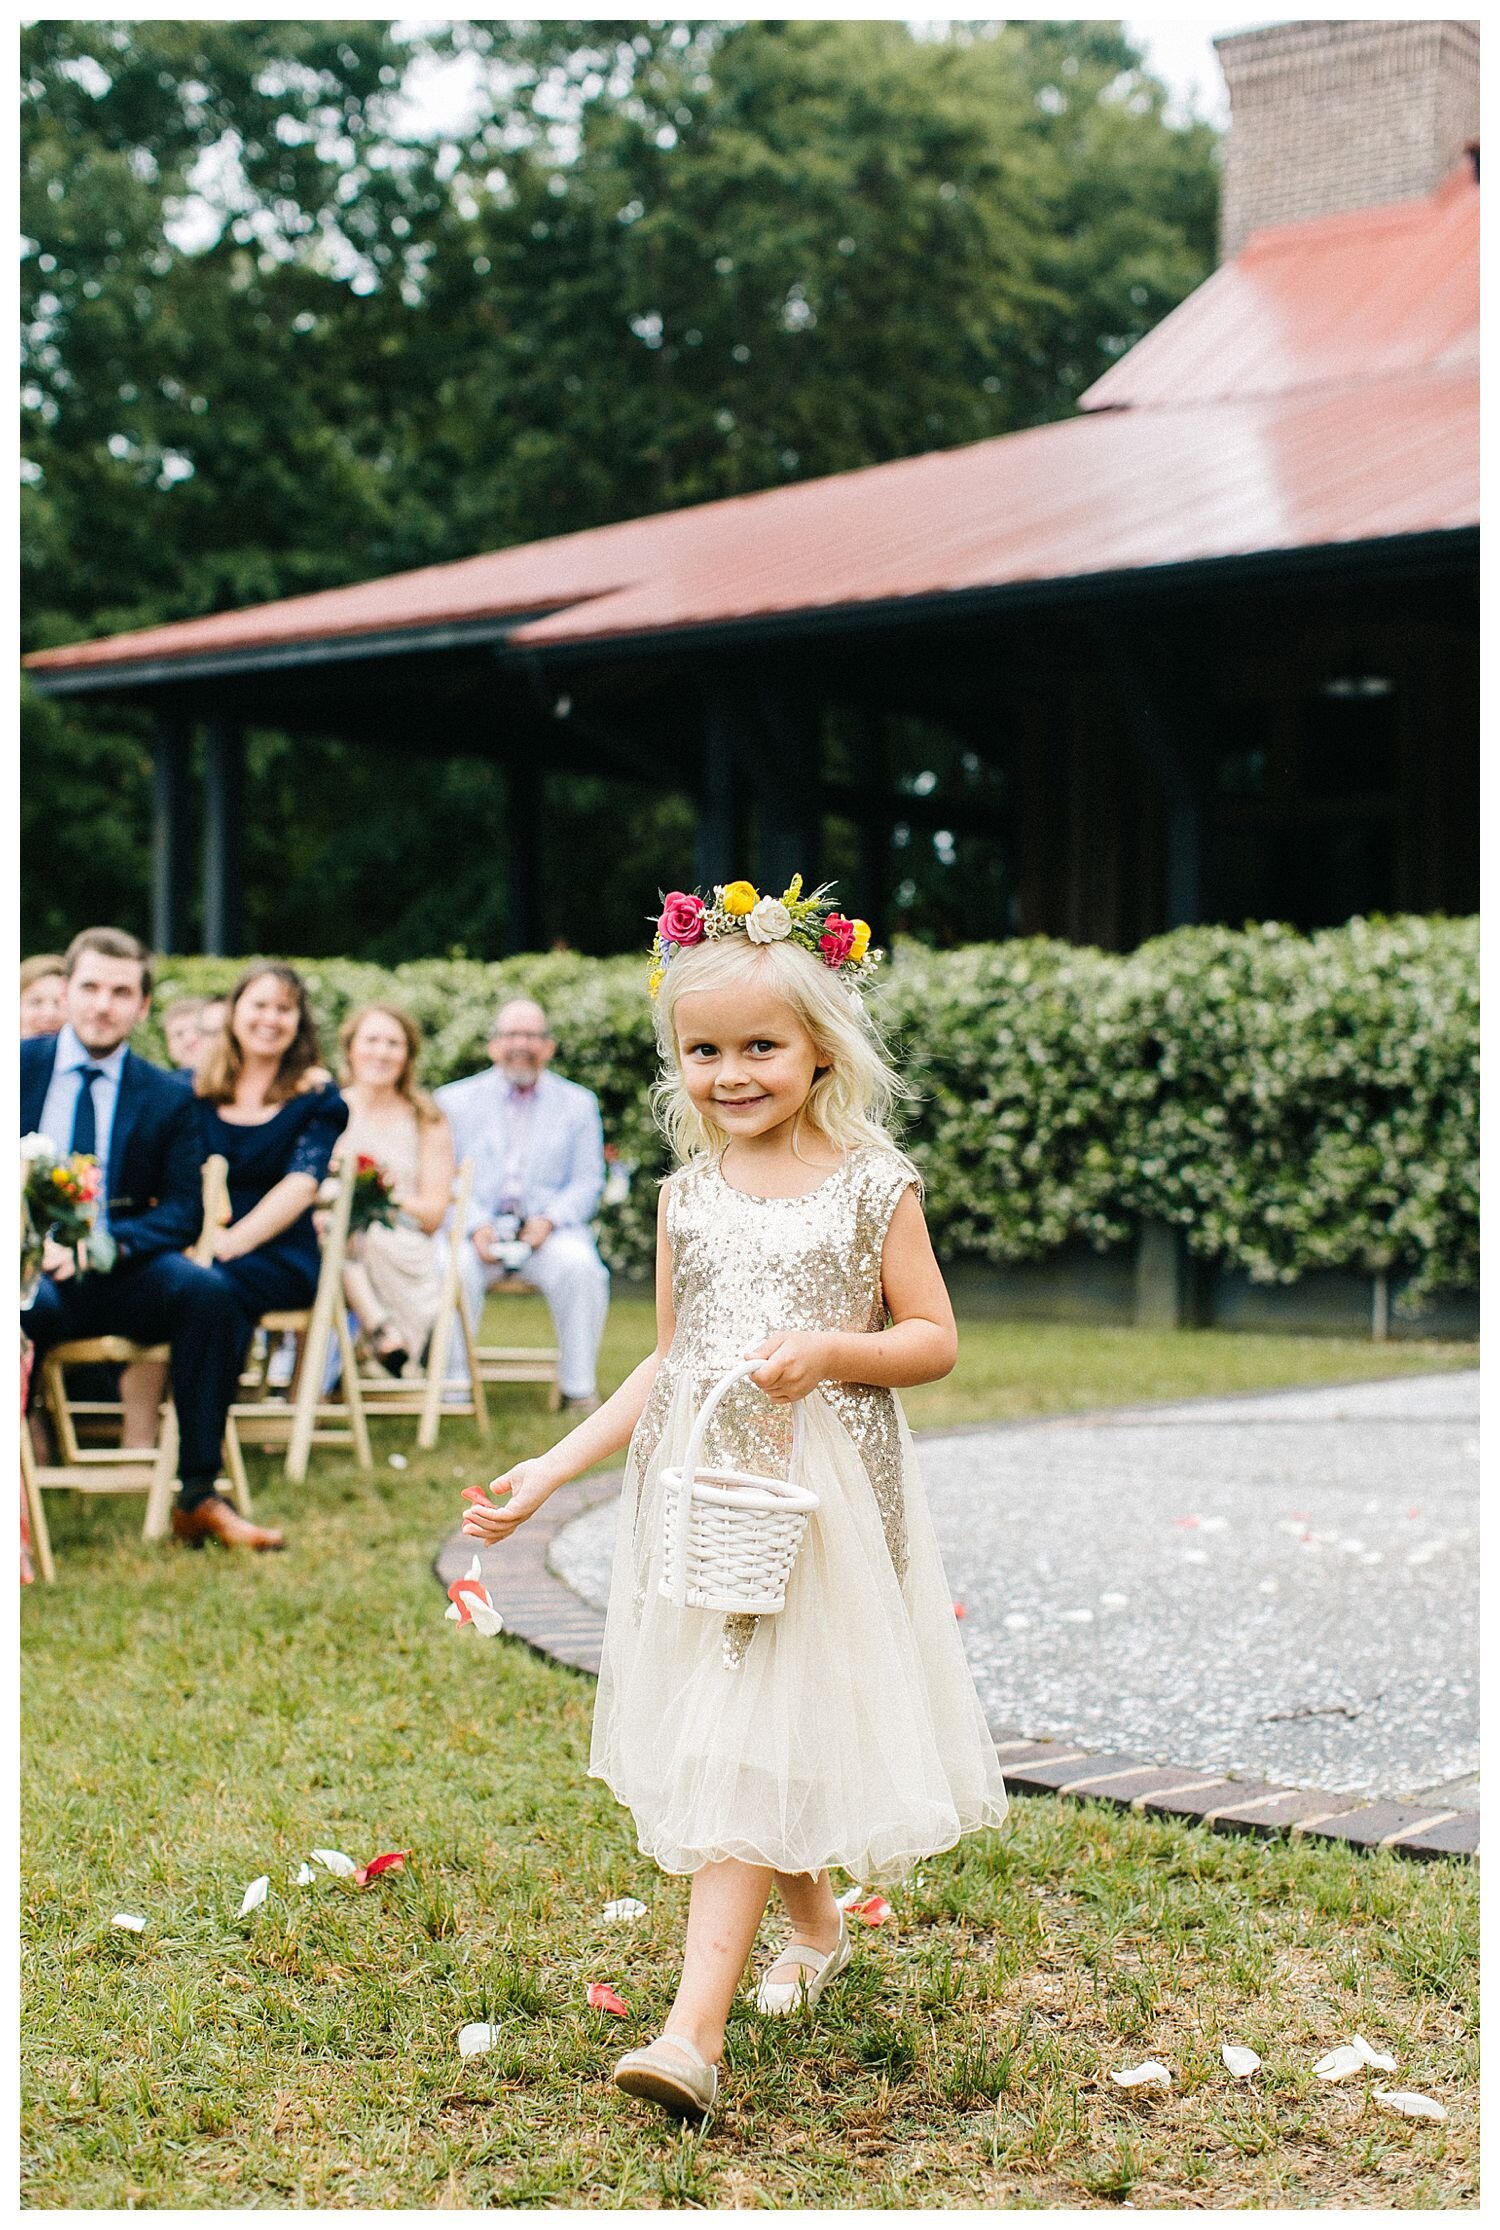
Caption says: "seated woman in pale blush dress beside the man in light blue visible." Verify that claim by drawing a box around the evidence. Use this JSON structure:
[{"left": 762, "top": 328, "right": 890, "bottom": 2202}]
[{"left": 339, "top": 1001, "right": 452, "bottom": 1376}]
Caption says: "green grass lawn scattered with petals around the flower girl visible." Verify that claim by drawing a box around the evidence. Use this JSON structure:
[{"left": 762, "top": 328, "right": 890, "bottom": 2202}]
[{"left": 22, "top": 1302, "right": 1478, "bottom": 2208}]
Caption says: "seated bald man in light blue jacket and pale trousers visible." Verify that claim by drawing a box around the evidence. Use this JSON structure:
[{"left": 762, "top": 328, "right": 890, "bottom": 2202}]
[{"left": 435, "top": 999, "right": 608, "bottom": 1409}]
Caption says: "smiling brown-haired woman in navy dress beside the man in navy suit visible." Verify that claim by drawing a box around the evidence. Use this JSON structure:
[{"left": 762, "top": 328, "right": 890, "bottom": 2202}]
[{"left": 174, "top": 961, "right": 350, "bottom": 1548}]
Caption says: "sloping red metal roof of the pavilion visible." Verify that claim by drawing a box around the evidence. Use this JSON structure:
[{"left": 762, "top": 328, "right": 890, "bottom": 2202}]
[{"left": 27, "top": 176, "right": 1478, "bottom": 671}]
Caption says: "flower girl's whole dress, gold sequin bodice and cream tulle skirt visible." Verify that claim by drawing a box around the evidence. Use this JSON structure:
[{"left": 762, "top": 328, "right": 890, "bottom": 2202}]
[{"left": 588, "top": 1146, "right": 1005, "bottom": 1882}]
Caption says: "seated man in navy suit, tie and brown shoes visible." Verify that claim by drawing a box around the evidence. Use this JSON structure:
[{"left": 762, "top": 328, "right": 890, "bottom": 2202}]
[{"left": 20, "top": 930, "right": 281, "bottom": 1548}]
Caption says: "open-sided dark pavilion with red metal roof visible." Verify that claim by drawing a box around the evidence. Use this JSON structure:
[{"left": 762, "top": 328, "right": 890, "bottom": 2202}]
[{"left": 27, "top": 154, "right": 1478, "bottom": 952}]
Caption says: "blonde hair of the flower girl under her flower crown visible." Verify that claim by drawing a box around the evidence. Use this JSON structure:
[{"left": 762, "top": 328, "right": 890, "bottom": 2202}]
[{"left": 651, "top": 937, "right": 916, "bottom": 1177}]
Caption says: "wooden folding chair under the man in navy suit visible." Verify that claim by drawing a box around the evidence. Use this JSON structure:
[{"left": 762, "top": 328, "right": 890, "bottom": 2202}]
[{"left": 20, "top": 1153, "right": 250, "bottom": 1579}]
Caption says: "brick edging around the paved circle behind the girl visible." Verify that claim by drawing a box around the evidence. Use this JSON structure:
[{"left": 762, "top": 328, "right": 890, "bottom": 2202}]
[{"left": 432, "top": 1472, "right": 1480, "bottom": 1860}]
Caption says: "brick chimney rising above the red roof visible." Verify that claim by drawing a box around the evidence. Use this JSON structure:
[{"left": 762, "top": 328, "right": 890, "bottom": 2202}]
[{"left": 1215, "top": 20, "right": 1480, "bottom": 259}]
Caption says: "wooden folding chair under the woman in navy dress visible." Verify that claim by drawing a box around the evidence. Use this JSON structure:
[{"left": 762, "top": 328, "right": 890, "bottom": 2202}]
[{"left": 223, "top": 1153, "right": 374, "bottom": 1492}]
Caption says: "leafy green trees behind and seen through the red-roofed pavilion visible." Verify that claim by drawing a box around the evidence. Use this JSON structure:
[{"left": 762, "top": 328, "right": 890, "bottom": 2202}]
[{"left": 22, "top": 20, "right": 1217, "bottom": 959}]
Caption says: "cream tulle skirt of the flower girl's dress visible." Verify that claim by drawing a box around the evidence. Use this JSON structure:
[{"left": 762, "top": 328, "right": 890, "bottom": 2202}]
[{"left": 588, "top": 1374, "right": 1005, "bottom": 1882}]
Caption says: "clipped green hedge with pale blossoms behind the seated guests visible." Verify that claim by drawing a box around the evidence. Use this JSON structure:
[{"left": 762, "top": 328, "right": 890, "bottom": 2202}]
[{"left": 145, "top": 917, "right": 1478, "bottom": 1296}]
